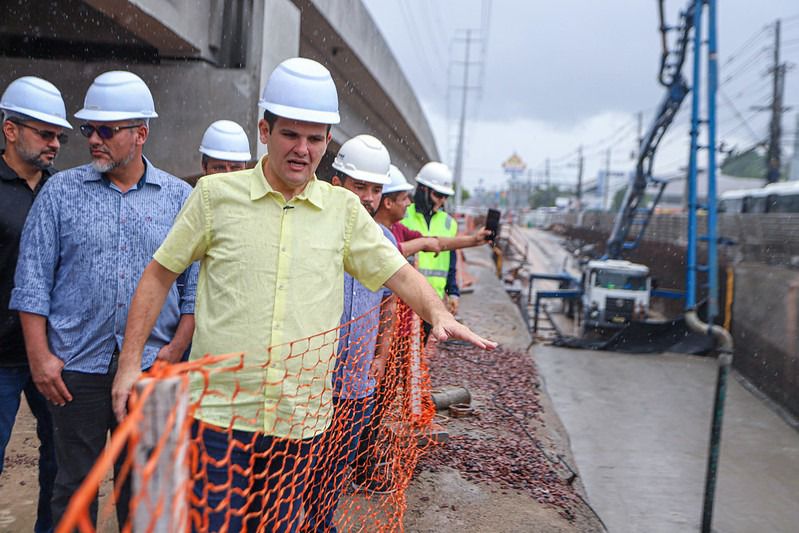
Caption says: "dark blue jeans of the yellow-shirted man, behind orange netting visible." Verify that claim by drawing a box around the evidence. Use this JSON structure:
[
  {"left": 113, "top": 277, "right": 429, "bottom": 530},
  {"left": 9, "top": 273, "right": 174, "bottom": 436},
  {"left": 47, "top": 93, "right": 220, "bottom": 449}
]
[{"left": 191, "top": 421, "right": 319, "bottom": 533}]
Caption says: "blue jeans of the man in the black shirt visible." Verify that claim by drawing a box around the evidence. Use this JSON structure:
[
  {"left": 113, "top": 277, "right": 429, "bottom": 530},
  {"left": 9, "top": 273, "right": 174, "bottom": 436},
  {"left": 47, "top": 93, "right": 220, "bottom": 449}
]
[{"left": 0, "top": 367, "right": 56, "bottom": 533}]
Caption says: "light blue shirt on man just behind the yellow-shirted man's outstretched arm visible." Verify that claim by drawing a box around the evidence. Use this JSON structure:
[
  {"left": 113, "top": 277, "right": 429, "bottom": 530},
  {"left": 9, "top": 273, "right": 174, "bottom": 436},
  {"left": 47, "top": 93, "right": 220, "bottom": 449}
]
[{"left": 333, "top": 225, "right": 397, "bottom": 400}]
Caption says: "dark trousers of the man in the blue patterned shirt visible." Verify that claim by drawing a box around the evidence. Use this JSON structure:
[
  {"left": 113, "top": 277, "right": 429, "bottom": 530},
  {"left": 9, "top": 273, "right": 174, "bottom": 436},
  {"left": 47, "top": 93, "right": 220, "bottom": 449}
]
[{"left": 50, "top": 355, "right": 130, "bottom": 529}]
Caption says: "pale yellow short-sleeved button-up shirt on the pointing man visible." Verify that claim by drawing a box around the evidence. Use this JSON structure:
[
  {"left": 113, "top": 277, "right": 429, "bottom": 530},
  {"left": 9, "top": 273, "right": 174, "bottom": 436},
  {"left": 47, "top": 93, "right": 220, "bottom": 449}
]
[{"left": 154, "top": 158, "right": 407, "bottom": 439}]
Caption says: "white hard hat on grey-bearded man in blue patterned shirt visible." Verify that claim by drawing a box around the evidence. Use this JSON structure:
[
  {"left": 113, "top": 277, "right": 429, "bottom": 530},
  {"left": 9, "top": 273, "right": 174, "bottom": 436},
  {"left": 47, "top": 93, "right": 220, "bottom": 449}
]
[{"left": 75, "top": 70, "right": 158, "bottom": 121}]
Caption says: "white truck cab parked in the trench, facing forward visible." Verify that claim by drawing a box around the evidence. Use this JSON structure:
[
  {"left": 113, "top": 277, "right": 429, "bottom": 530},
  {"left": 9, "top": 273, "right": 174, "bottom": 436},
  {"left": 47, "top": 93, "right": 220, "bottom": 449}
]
[{"left": 582, "top": 259, "right": 652, "bottom": 329}]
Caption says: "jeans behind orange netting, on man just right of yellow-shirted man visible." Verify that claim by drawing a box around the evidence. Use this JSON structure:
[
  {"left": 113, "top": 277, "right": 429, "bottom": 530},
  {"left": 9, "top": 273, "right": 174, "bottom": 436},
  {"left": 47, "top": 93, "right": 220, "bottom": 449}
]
[{"left": 303, "top": 395, "right": 374, "bottom": 533}]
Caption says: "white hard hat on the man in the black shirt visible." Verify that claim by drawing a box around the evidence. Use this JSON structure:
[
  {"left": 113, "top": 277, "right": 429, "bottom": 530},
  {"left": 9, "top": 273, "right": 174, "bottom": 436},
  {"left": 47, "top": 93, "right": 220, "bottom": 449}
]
[{"left": 0, "top": 76, "right": 72, "bottom": 129}]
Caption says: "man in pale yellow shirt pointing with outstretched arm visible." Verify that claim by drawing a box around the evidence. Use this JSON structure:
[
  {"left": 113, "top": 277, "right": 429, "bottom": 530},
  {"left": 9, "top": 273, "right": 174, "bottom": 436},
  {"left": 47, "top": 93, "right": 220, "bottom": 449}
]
[{"left": 114, "top": 58, "right": 496, "bottom": 531}]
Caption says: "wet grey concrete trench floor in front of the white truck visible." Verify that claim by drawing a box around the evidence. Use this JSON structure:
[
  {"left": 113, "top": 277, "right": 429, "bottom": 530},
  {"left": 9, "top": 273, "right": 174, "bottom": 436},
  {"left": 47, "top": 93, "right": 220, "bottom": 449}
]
[{"left": 533, "top": 345, "right": 799, "bottom": 532}]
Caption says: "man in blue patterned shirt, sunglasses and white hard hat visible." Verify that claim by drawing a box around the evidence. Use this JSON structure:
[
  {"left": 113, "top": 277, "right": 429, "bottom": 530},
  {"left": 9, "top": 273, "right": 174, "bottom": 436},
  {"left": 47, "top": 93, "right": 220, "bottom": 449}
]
[{"left": 10, "top": 71, "right": 197, "bottom": 525}]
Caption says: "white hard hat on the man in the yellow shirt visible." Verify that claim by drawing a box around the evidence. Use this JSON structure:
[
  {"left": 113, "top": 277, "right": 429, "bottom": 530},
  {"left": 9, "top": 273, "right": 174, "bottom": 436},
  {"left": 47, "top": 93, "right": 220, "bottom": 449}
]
[{"left": 258, "top": 57, "right": 341, "bottom": 124}]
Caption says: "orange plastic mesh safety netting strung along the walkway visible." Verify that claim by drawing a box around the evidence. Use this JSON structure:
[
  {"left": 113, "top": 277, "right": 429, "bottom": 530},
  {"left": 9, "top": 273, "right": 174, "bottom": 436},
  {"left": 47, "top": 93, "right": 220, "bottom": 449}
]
[{"left": 57, "top": 302, "right": 435, "bottom": 532}]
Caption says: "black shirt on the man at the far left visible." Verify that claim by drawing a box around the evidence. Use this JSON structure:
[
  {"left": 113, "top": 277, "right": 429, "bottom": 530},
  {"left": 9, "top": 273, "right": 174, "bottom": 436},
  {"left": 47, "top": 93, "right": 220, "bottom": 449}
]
[{"left": 0, "top": 150, "right": 55, "bottom": 367}]
